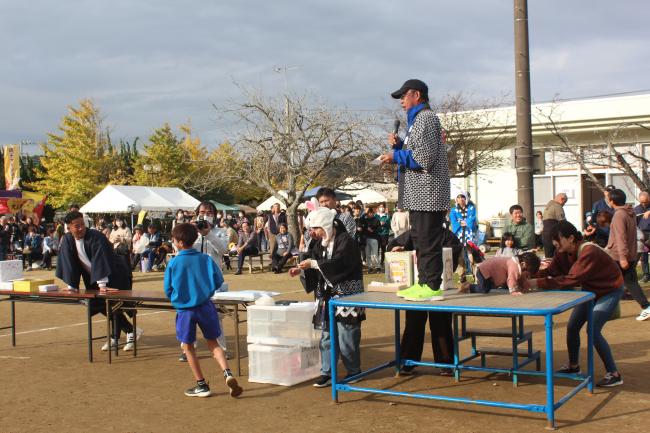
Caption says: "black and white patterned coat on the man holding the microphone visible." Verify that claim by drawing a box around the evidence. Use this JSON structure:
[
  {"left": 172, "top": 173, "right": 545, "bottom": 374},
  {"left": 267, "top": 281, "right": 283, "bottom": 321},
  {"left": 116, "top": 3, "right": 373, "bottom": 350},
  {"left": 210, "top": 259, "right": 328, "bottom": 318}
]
[{"left": 403, "top": 109, "right": 451, "bottom": 212}]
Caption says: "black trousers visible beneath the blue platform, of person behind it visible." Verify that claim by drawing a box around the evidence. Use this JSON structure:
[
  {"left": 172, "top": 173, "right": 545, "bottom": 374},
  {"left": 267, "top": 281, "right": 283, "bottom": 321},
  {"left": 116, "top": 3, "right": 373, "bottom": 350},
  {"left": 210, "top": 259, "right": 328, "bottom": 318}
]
[{"left": 400, "top": 311, "right": 454, "bottom": 364}]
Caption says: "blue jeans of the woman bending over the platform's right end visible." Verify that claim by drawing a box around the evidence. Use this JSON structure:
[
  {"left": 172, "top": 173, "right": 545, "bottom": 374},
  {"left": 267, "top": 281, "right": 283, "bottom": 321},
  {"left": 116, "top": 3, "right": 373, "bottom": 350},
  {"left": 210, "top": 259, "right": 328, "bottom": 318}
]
[{"left": 566, "top": 287, "right": 623, "bottom": 373}]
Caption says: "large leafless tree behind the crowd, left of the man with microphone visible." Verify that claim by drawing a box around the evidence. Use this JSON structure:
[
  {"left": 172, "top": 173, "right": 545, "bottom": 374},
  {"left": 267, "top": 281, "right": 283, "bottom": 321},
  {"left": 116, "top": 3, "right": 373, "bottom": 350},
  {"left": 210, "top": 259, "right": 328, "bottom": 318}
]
[{"left": 219, "top": 91, "right": 378, "bottom": 239}]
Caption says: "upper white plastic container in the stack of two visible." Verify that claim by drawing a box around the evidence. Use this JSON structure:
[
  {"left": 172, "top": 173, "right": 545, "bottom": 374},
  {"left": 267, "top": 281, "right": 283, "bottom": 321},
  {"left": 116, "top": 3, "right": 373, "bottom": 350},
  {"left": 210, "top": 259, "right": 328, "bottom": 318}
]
[{"left": 246, "top": 302, "right": 320, "bottom": 347}]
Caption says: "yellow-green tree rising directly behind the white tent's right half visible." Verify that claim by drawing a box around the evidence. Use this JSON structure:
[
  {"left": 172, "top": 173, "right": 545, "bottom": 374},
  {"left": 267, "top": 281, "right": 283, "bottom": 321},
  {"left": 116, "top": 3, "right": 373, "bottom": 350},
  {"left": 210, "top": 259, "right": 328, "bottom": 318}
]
[{"left": 133, "top": 123, "right": 189, "bottom": 187}]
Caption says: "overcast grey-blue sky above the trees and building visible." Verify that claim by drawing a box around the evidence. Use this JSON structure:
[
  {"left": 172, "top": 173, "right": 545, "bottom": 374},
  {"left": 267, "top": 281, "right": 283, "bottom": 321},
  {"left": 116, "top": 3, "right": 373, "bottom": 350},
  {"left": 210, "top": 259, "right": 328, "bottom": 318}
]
[{"left": 0, "top": 0, "right": 650, "bottom": 153}]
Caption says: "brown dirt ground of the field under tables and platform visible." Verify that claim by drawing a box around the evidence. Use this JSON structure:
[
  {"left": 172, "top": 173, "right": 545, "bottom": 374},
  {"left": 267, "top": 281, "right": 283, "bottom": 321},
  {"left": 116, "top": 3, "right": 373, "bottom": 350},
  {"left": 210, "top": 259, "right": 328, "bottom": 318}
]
[{"left": 0, "top": 271, "right": 650, "bottom": 433}]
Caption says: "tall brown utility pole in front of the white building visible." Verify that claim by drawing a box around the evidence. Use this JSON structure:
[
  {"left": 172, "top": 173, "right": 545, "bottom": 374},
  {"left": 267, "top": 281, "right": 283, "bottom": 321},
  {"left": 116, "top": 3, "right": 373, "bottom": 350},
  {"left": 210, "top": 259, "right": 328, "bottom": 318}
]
[{"left": 514, "top": 0, "right": 535, "bottom": 224}]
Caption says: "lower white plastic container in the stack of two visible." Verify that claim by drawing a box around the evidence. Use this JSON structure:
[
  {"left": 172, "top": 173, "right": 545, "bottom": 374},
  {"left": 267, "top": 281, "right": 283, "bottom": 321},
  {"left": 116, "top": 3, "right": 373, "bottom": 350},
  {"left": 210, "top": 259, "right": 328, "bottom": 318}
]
[{"left": 248, "top": 344, "right": 320, "bottom": 386}]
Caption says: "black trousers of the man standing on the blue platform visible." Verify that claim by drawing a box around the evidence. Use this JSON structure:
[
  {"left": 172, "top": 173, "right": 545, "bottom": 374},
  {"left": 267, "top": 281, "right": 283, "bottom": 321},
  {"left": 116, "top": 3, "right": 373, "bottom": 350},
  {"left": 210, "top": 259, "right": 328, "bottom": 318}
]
[{"left": 409, "top": 211, "right": 446, "bottom": 290}]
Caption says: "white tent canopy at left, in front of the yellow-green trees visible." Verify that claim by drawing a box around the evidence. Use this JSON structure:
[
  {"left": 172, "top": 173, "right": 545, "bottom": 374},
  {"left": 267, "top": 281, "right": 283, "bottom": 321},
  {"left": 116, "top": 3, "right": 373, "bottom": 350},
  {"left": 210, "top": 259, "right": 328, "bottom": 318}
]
[{"left": 80, "top": 185, "right": 200, "bottom": 213}]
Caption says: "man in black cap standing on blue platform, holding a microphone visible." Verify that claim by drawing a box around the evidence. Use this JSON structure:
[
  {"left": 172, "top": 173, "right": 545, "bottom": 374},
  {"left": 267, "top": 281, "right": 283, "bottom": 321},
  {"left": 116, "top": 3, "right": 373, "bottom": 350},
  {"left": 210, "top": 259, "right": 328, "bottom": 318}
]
[{"left": 380, "top": 79, "right": 450, "bottom": 301}]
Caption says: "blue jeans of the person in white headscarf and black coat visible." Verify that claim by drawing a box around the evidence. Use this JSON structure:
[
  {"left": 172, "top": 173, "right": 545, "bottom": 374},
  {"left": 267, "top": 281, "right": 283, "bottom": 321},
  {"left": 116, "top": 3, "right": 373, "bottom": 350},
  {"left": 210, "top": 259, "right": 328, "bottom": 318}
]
[{"left": 318, "top": 322, "right": 361, "bottom": 376}]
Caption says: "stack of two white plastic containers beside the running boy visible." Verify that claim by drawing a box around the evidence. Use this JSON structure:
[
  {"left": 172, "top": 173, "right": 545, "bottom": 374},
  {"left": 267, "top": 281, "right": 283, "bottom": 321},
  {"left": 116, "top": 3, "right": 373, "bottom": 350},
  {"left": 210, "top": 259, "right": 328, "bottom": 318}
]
[{"left": 247, "top": 302, "right": 320, "bottom": 386}]
